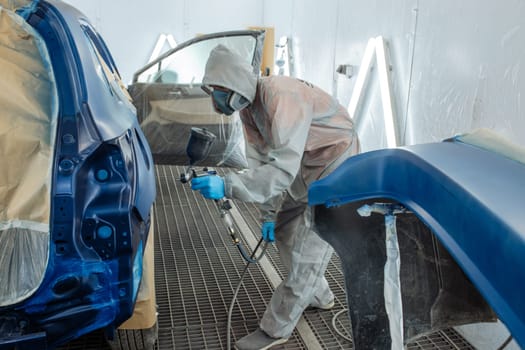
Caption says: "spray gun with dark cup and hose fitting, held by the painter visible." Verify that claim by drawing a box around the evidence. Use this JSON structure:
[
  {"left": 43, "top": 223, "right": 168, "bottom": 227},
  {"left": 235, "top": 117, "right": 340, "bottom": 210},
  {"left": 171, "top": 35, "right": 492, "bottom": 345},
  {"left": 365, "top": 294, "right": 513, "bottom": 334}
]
[{"left": 180, "top": 127, "right": 266, "bottom": 263}]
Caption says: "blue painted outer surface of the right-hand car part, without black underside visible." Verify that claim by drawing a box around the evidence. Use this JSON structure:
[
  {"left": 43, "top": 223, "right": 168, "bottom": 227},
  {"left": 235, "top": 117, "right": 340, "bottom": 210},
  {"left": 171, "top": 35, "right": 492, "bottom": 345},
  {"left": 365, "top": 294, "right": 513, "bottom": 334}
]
[{"left": 309, "top": 142, "right": 525, "bottom": 346}]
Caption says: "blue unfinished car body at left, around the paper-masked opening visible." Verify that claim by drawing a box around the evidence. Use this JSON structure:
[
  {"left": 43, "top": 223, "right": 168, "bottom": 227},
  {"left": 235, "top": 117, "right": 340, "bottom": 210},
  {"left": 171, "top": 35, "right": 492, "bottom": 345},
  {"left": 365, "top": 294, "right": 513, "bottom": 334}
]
[{"left": 0, "top": 0, "right": 156, "bottom": 349}]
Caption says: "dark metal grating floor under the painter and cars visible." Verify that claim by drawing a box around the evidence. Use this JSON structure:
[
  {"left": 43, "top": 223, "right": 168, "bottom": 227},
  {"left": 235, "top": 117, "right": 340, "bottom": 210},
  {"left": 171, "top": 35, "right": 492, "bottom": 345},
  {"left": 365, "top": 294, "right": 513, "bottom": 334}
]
[{"left": 59, "top": 165, "right": 474, "bottom": 350}]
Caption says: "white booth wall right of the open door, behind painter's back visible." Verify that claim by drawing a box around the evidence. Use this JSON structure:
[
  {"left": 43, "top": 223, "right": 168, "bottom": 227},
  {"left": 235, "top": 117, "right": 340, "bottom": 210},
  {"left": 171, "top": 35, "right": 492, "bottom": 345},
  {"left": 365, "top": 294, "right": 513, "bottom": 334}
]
[{"left": 265, "top": 0, "right": 525, "bottom": 150}]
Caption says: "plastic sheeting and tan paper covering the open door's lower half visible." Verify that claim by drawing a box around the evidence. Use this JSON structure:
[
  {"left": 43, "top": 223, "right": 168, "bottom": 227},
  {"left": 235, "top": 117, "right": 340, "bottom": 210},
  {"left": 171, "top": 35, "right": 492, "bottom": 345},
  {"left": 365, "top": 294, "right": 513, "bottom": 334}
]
[{"left": 131, "top": 84, "right": 248, "bottom": 169}]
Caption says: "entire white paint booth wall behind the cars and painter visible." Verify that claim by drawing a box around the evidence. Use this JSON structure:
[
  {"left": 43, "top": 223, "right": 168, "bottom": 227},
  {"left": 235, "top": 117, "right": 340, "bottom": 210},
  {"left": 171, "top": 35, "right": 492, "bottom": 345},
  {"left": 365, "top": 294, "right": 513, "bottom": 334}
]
[{"left": 63, "top": 0, "right": 525, "bottom": 150}]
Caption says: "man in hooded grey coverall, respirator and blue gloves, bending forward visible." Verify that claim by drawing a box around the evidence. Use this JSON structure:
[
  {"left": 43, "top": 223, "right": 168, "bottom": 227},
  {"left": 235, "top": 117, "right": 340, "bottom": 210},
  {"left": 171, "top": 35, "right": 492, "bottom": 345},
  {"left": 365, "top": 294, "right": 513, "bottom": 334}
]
[{"left": 192, "top": 45, "right": 359, "bottom": 350}]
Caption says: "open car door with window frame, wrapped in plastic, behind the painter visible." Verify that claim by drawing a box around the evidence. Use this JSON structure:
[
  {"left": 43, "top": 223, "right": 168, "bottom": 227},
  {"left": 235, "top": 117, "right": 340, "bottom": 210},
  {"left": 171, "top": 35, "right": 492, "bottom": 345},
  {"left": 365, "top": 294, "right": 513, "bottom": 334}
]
[{"left": 129, "top": 30, "right": 265, "bottom": 168}]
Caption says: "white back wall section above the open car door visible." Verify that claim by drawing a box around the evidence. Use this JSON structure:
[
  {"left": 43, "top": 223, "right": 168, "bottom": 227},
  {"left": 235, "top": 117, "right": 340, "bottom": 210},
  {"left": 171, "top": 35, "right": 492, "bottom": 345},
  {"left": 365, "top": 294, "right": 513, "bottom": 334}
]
[{"left": 66, "top": 0, "right": 264, "bottom": 83}]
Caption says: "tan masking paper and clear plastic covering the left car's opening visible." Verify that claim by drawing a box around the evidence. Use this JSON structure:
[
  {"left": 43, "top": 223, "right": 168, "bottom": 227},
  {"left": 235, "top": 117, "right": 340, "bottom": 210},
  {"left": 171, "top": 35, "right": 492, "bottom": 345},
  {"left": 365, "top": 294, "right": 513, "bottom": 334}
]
[{"left": 0, "top": 1, "right": 58, "bottom": 306}]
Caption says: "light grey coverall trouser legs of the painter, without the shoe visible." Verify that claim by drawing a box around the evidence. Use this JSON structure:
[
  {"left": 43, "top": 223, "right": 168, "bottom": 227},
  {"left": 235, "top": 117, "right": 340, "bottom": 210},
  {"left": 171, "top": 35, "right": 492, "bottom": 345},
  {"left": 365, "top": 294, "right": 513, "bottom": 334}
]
[{"left": 260, "top": 194, "right": 333, "bottom": 338}]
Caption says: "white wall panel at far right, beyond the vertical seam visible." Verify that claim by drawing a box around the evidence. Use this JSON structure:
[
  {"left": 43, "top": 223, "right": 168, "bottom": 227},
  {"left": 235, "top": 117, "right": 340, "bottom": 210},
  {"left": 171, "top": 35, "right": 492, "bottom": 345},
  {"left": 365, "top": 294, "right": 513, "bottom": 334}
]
[{"left": 409, "top": 0, "right": 525, "bottom": 145}]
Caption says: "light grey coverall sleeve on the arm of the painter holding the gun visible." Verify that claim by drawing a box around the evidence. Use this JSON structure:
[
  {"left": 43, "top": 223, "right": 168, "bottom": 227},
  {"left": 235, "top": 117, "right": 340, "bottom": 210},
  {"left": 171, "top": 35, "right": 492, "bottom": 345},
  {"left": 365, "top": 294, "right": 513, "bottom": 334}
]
[{"left": 225, "top": 92, "right": 312, "bottom": 220}]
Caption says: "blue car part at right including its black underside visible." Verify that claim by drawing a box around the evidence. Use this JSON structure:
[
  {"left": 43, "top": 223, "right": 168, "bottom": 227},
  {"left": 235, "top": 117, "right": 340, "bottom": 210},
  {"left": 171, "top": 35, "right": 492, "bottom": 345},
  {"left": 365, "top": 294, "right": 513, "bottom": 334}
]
[{"left": 309, "top": 129, "right": 525, "bottom": 349}]
